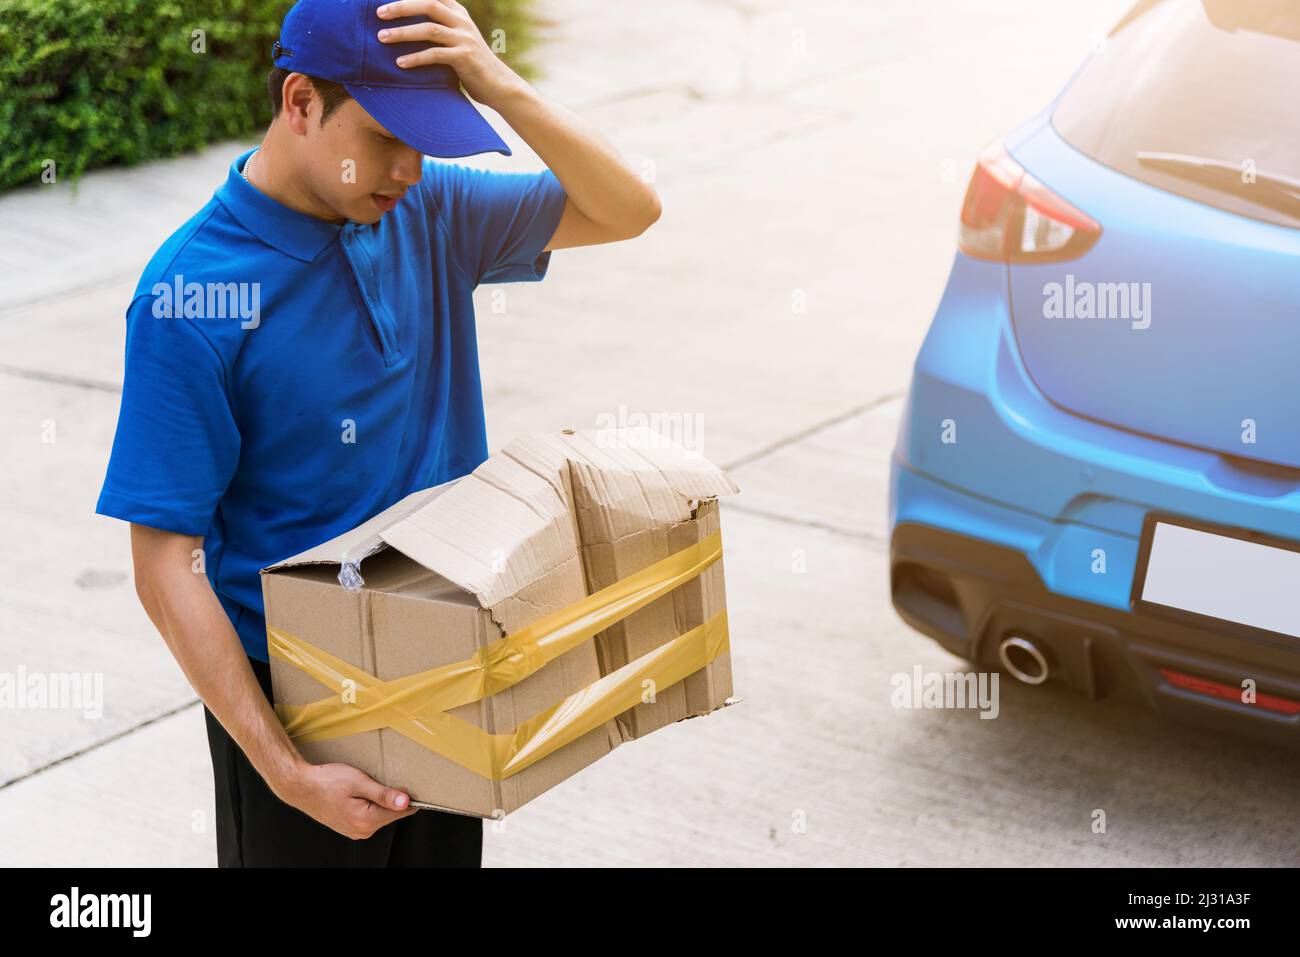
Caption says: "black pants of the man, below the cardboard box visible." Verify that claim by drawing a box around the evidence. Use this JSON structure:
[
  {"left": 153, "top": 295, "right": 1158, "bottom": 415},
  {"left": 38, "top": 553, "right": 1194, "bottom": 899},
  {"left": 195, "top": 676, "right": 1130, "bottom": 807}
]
[{"left": 203, "top": 658, "right": 484, "bottom": 867}]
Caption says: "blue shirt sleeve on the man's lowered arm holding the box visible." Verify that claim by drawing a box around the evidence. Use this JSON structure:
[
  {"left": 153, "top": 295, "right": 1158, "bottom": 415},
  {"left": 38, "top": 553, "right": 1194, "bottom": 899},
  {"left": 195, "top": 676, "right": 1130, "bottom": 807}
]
[{"left": 95, "top": 295, "right": 239, "bottom": 534}]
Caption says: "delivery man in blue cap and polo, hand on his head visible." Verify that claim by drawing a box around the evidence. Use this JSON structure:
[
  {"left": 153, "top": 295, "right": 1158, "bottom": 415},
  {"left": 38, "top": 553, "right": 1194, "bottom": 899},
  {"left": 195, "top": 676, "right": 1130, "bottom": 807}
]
[{"left": 96, "top": 0, "right": 659, "bottom": 866}]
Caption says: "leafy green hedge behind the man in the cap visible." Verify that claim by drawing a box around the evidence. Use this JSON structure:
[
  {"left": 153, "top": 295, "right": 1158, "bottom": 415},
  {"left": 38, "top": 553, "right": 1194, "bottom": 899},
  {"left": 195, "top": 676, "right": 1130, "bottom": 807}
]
[{"left": 0, "top": 0, "right": 532, "bottom": 190}]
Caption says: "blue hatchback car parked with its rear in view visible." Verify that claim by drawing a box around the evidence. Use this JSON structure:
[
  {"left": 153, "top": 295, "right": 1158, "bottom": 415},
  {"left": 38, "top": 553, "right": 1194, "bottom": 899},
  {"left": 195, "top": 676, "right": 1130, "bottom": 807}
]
[{"left": 889, "top": 0, "right": 1300, "bottom": 746}]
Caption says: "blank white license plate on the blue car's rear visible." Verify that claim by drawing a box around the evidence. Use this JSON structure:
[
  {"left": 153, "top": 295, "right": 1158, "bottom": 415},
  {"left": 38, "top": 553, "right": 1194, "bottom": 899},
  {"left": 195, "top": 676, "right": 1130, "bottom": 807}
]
[{"left": 1140, "top": 521, "right": 1300, "bottom": 637}]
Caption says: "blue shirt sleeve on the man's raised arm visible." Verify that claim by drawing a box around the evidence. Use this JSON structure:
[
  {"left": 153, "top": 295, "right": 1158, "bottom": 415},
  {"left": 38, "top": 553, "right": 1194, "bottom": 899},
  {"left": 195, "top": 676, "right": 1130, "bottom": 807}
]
[{"left": 423, "top": 160, "right": 568, "bottom": 285}]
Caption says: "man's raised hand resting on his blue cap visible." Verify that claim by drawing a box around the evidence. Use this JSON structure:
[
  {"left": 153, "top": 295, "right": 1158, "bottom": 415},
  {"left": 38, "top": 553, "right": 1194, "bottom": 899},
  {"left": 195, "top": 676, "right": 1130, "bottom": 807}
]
[{"left": 377, "top": 0, "right": 523, "bottom": 107}]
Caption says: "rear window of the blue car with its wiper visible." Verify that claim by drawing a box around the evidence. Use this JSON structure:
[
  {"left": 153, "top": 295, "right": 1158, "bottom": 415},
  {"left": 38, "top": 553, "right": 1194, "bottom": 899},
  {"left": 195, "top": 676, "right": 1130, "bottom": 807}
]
[{"left": 1052, "top": 0, "right": 1300, "bottom": 226}]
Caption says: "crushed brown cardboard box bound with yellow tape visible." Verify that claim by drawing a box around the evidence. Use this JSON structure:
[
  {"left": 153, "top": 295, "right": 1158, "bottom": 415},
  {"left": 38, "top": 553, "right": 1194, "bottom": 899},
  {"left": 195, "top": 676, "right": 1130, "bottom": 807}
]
[{"left": 261, "top": 429, "right": 738, "bottom": 818}]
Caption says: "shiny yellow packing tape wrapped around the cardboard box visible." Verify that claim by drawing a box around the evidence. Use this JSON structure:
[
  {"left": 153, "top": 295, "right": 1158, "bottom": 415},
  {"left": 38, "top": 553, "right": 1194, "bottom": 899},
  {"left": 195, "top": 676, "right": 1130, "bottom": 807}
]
[{"left": 267, "top": 532, "right": 728, "bottom": 780}]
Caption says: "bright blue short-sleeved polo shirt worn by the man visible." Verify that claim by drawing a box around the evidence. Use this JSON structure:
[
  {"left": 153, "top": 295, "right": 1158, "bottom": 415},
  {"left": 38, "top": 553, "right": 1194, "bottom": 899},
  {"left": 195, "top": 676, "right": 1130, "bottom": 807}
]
[{"left": 95, "top": 150, "right": 566, "bottom": 661}]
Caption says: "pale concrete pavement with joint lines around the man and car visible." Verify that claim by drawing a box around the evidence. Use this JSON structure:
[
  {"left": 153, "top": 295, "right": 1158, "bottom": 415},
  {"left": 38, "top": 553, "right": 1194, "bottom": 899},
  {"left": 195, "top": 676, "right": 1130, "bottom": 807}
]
[{"left": 0, "top": 0, "right": 1300, "bottom": 866}]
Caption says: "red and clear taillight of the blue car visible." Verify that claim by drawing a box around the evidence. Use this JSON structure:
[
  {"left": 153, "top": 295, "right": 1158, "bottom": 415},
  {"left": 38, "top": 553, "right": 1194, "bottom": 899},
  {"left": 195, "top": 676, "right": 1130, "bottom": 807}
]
[{"left": 957, "top": 143, "right": 1101, "bottom": 263}]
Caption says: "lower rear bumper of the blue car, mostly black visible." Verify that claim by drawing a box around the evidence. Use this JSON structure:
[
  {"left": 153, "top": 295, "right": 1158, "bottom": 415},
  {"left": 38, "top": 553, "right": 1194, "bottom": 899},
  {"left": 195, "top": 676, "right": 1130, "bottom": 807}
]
[{"left": 889, "top": 459, "right": 1300, "bottom": 748}]
